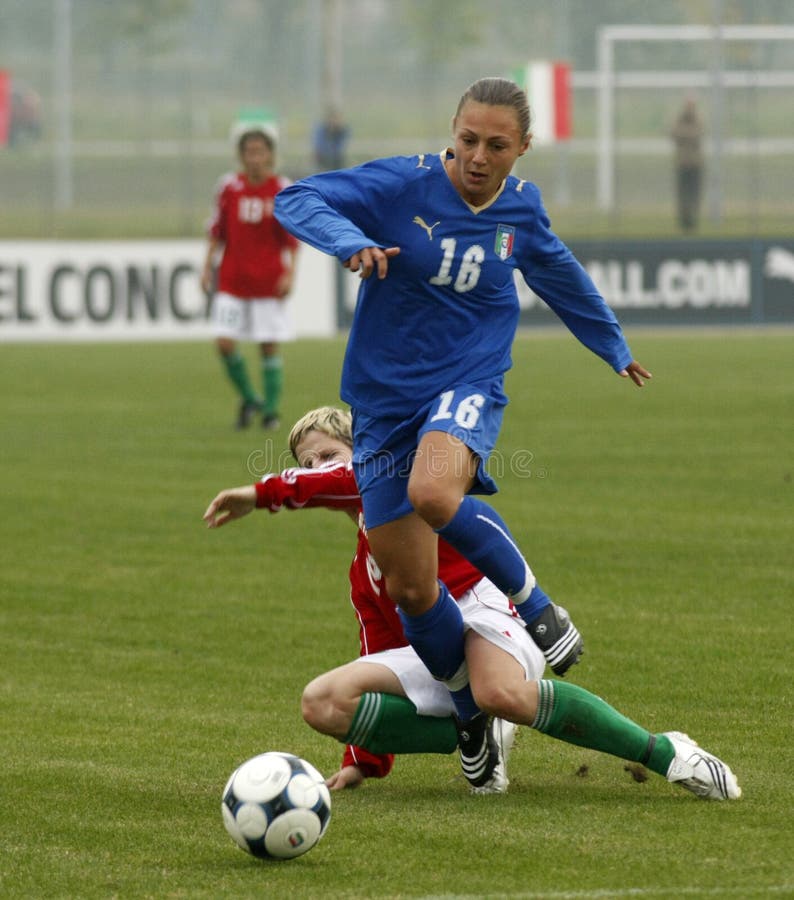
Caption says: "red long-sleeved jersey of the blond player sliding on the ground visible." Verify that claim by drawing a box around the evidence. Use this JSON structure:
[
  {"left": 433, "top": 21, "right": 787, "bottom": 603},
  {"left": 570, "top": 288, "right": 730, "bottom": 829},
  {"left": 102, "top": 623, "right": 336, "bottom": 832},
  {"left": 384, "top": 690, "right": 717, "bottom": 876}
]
[{"left": 256, "top": 463, "right": 482, "bottom": 778}]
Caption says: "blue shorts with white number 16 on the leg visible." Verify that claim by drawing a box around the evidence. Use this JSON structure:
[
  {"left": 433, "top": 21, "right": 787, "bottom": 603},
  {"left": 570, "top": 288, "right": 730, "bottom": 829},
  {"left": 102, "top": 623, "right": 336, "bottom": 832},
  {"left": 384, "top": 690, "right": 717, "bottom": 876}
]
[{"left": 353, "top": 378, "right": 507, "bottom": 528}]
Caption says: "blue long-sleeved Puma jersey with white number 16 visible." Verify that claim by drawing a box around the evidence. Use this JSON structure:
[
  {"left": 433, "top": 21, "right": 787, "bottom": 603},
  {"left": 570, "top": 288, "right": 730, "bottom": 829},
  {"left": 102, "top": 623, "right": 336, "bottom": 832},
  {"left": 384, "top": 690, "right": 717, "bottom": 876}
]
[{"left": 275, "top": 150, "right": 632, "bottom": 417}]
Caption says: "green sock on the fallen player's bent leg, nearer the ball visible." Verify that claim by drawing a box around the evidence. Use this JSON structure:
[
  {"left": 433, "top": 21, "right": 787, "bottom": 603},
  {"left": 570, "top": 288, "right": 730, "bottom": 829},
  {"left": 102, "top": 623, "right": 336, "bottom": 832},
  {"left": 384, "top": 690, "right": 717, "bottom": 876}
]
[{"left": 343, "top": 693, "right": 458, "bottom": 753}]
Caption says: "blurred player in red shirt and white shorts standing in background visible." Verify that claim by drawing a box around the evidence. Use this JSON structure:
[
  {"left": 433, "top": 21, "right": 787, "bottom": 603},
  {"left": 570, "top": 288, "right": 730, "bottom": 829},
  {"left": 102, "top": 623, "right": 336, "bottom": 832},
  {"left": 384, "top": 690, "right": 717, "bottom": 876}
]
[{"left": 201, "top": 123, "right": 298, "bottom": 429}]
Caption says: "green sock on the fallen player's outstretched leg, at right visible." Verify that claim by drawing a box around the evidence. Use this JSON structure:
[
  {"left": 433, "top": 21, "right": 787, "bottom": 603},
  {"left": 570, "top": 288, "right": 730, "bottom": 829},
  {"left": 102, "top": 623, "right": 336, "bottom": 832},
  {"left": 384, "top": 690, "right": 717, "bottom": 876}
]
[{"left": 532, "top": 679, "right": 675, "bottom": 775}]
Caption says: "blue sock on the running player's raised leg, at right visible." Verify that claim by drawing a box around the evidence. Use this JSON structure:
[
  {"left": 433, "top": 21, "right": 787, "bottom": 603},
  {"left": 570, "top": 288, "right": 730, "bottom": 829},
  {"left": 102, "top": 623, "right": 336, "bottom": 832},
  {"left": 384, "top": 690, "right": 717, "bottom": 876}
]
[{"left": 438, "top": 494, "right": 551, "bottom": 623}]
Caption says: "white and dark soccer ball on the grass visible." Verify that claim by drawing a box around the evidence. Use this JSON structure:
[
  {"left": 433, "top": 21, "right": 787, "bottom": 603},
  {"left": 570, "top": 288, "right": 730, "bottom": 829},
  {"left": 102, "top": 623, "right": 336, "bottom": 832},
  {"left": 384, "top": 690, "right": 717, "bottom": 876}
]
[{"left": 221, "top": 751, "right": 331, "bottom": 859}]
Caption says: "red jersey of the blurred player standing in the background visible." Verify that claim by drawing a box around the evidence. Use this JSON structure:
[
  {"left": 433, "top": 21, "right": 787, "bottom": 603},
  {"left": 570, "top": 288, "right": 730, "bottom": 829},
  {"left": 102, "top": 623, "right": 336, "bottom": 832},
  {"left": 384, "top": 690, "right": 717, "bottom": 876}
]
[{"left": 207, "top": 172, "right": 298, "bottom": 300}]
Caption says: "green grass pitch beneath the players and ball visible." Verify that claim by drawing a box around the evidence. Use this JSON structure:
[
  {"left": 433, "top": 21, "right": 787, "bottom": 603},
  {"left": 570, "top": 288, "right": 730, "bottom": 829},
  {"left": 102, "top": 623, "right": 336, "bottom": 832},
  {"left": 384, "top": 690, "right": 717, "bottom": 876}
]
[{"left": 0, "top": 331, "right": 794, "bottom": 900}]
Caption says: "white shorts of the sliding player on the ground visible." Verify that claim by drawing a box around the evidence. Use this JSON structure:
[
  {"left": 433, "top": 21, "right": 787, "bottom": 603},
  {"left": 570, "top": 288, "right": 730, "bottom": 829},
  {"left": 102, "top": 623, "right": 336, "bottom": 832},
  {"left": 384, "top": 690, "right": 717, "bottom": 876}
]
[{"left": 356, "top": 578, "right": 546, "bottom": 717}]
